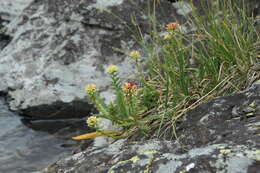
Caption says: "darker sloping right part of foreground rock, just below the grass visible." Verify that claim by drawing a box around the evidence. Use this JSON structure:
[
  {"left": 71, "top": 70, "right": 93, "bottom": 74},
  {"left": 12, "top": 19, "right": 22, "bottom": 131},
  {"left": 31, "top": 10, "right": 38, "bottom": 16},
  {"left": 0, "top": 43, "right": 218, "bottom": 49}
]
[{"left": 178, "top": 83, "right": 260, "bottom": 148}]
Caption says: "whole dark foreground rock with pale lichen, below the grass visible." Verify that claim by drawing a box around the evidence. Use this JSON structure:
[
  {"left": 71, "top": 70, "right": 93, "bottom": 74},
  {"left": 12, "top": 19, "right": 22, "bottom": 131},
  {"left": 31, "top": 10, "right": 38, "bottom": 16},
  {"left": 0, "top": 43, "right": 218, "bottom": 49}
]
[{"left": 43, "top": 83, "right": 260, "bottom": 173}]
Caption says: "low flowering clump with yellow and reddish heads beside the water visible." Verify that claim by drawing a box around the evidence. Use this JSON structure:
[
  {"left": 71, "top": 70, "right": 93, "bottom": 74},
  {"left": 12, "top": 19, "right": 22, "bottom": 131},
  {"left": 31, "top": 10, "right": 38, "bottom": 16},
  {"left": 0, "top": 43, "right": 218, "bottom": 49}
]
[{"left": 73, "top": 58, "right": 159, "bottom": 140}]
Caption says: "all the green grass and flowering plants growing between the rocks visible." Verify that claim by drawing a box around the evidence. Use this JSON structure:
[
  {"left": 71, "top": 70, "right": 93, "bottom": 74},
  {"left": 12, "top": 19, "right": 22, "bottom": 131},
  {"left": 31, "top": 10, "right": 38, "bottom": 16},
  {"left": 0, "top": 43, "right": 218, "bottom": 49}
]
[{"left": 73, "top": 0, "right": 260, "bottom": 139}]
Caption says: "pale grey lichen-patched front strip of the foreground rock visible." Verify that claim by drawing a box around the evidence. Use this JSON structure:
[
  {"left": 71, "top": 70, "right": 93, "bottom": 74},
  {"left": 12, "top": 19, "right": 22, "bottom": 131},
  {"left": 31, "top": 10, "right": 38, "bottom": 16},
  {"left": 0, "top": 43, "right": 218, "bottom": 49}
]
[{"left": 43, "top": 140, "right": 259, "bottom": 173}]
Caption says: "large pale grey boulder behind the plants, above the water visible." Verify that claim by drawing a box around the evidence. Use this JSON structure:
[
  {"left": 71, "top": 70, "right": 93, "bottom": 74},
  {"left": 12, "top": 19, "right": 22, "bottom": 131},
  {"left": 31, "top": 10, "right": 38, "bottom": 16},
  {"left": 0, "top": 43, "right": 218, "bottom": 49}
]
[{"left": 0, "top": 0, "right": 185, "bottom": 119}]
